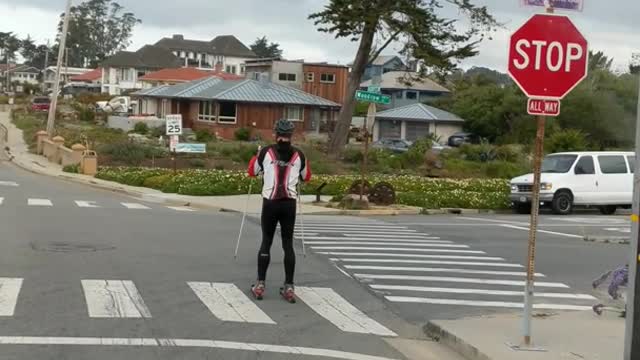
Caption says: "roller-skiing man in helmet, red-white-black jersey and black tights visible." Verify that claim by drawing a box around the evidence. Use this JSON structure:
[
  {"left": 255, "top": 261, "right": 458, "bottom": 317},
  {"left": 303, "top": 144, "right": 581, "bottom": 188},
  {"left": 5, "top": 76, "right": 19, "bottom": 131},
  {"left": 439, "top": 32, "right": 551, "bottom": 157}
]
[{"left": 249, "top": 120, "right": 311, "bottom": 303}]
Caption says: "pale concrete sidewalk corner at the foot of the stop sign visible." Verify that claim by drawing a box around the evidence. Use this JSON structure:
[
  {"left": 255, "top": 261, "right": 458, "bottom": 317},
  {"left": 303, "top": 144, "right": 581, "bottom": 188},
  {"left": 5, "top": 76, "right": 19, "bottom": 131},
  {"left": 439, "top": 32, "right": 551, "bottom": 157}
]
[{"left": 425, "top": 311, "right": 625, "bottom": 360}]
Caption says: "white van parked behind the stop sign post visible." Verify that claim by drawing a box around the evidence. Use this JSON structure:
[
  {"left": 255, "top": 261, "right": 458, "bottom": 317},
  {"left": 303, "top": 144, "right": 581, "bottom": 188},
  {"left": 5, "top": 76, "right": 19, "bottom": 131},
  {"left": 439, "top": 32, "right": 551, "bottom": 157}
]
[{"left": 510, "top": 151, "right": 636, "bottom": 215}]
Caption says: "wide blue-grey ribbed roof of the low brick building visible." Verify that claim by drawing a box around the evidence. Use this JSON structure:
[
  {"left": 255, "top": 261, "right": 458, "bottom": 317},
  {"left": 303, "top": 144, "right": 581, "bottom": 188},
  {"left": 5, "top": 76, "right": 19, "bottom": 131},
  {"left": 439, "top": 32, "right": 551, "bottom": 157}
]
[{"left": 134, "top": 76, "right": 340, "bottom": 107}]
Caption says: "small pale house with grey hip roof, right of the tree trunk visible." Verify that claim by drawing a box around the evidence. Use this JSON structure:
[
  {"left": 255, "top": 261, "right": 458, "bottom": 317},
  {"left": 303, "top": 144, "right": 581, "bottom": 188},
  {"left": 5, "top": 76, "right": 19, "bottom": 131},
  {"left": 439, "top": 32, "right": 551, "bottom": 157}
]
[{"left": 373, "top": 103, "right": 464, "bottom": 141}]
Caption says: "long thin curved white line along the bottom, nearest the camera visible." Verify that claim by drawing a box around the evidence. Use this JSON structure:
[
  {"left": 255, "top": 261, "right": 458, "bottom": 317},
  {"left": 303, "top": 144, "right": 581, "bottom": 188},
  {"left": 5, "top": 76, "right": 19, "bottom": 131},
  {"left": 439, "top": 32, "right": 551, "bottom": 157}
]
[{"left": 0, "top": 336, "right": 394, "bottom": 360}]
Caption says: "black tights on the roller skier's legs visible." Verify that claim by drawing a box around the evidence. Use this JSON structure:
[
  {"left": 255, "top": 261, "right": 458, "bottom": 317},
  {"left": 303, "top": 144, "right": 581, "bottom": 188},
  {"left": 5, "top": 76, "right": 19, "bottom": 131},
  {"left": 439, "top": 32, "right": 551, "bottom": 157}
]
[{"left": 258, "top": 199, "right": 296, "bottom": 284}]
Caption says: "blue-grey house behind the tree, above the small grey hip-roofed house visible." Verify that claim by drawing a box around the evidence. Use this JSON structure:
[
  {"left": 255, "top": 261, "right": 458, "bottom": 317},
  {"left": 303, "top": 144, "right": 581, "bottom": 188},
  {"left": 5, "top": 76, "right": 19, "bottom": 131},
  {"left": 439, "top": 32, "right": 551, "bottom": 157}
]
[{"left": 360, "top": 71, "right": 450, "bottom": 108}]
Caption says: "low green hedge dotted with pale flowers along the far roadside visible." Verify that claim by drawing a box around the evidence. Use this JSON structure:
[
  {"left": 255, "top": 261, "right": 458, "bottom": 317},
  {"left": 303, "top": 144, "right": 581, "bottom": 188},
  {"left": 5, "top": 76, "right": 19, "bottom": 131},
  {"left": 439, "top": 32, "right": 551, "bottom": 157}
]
[{"left": 96, "top": 167, "right": 510, "bottom": 209}]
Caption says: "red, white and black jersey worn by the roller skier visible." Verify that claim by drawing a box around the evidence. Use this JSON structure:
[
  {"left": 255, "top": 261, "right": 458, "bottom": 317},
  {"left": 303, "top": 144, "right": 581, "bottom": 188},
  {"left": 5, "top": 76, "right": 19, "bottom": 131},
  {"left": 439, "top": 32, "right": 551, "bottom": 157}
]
[{"left": 249, "top": 145, "right": 311, "bottom": 200}]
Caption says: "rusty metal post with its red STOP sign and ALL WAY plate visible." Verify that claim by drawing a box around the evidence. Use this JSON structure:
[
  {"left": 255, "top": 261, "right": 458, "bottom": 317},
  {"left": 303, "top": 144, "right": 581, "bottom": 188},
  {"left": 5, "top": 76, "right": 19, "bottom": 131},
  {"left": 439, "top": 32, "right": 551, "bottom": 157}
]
[{"left": 508, "top": 2, "right": 589, "bottom": 351}]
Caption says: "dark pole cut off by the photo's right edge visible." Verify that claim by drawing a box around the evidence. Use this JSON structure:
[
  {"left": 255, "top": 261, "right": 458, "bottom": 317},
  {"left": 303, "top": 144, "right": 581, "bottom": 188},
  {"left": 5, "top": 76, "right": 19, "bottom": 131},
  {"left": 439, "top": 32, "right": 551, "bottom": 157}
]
[{"left": 624, "top": 51, "right": 640, "bottom": 360}]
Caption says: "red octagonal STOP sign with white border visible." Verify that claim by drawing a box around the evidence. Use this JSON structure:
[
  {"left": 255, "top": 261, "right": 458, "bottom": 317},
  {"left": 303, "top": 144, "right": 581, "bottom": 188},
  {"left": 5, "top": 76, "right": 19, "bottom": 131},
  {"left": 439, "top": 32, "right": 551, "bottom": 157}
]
[{"left": 509, "top": 14, "right": 589, "bottom": 100}]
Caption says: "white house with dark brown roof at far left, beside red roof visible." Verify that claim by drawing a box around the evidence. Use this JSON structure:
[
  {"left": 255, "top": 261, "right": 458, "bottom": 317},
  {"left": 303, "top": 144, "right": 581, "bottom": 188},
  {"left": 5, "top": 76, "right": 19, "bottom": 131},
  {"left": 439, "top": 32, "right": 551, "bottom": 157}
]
[{"left": 101, "top": 45, "right": 182, "bottom": 95}]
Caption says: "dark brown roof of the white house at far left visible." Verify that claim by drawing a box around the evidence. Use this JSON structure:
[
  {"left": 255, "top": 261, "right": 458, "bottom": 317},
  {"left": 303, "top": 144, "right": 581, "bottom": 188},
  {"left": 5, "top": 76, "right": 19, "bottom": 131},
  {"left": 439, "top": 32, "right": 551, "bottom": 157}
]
[{"left": 102, "top": 45, "right": 181, "bottom": 69}]
